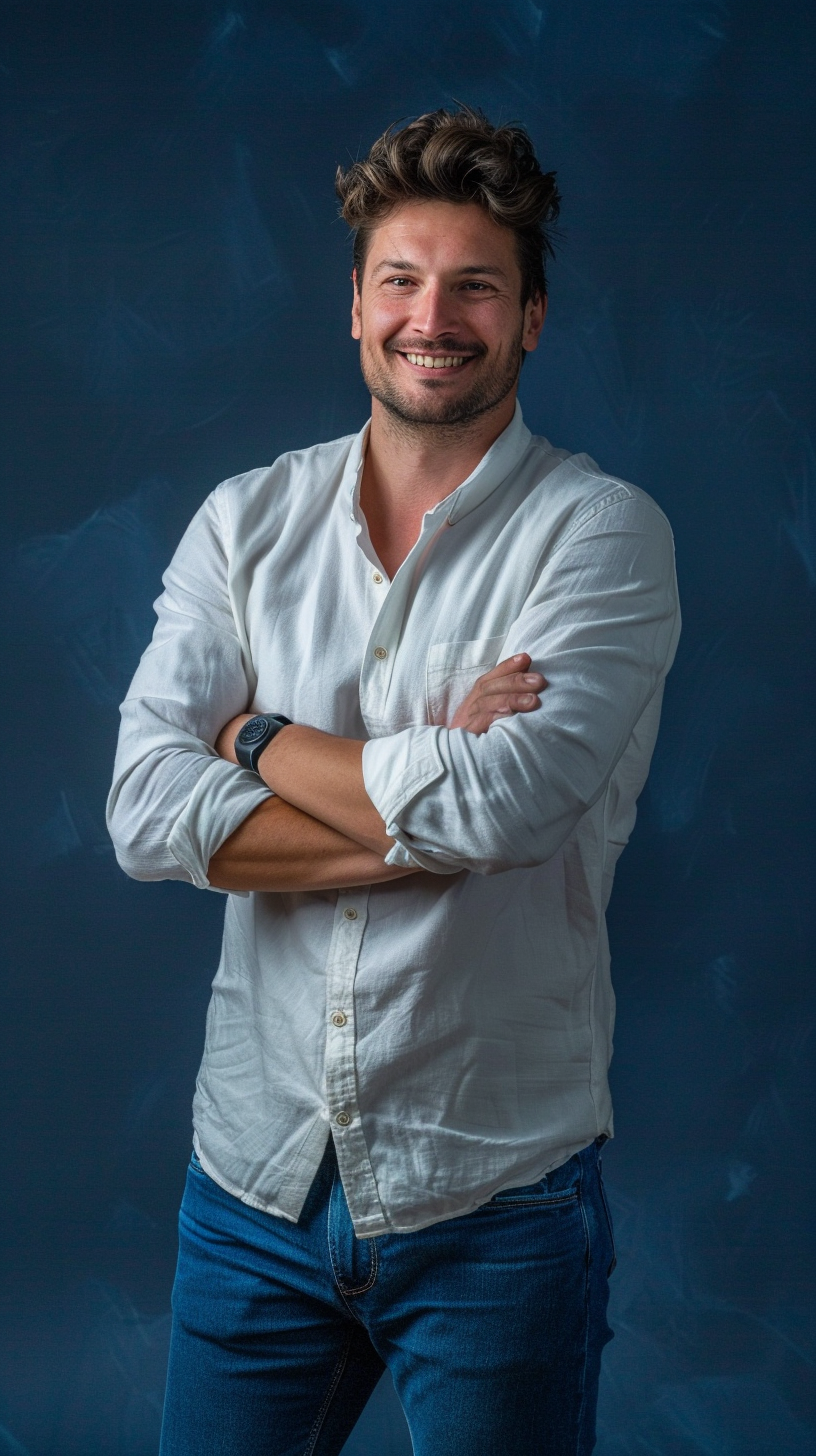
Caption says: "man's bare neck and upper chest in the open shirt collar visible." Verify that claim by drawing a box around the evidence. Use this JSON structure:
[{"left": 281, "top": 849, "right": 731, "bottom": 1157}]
[{"left": 360, "top": 390, "right": 516, "bottom": 577}]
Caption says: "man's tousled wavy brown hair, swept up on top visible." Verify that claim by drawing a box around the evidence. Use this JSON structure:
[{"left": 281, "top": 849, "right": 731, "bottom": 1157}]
[{"left": 335, "top": 106, "right": 561, "bottom": 306}]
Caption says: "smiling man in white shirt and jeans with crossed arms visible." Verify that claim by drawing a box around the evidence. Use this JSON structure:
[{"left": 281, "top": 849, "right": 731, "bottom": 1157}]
[{"left": 109, "top": 109, "right": 679, "bottom": 1456}]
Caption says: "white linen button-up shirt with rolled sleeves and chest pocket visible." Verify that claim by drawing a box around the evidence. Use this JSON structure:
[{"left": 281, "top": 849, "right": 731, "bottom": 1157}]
[{"left": 108, "top": 408, "right": 679, "bottom": 1238}]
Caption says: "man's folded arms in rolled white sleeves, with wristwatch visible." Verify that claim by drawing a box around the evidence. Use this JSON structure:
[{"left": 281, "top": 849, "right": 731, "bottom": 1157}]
[{"left": 109, "top": 498, "right": 679, "bottom": 891}]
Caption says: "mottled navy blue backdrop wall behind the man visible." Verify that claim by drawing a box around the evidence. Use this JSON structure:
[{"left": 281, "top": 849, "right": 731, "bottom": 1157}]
[{"left": 0, "top": 0, "right": 816, "bottom": 1456}]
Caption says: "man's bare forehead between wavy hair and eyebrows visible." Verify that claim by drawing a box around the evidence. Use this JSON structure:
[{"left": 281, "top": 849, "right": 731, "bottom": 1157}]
[{"left": 366, "top": 201, "right": 519, "bottom": 277}]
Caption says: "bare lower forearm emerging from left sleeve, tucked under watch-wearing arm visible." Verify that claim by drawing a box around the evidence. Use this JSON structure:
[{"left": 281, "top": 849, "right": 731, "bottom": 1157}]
[{"left": 208, "top": 798, "right": 412, "bottom": 891}]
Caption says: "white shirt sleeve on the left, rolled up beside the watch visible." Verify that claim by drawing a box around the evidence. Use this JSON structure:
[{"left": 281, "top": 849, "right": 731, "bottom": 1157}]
[{"left": 106, "top": 491, "right": 271, "bottom": 888}]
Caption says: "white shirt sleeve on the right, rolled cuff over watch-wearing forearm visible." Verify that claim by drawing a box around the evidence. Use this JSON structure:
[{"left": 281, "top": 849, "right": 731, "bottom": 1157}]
[{"left": 363, "top": 492, "right": 679, "bottom": 874}]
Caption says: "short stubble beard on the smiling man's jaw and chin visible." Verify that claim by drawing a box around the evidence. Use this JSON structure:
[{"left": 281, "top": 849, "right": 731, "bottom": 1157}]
[{"left": 360, "top": 328, "right": 523, "bottom": 435}]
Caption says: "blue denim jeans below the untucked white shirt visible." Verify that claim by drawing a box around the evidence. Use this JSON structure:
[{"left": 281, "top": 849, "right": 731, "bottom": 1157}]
[{"left": 162, "top": 1139, "right": 613, "bottom": 1456}]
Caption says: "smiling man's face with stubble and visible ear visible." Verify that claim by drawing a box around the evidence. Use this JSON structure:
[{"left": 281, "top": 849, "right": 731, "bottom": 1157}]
[{"left": 351, "top": 202, "right": 546, "bottom": 427}]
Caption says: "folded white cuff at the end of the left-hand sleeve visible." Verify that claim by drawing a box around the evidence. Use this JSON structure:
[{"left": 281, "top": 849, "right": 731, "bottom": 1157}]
[{"left": 168, "top": 759, "right": 274, "bottom": 894}]
